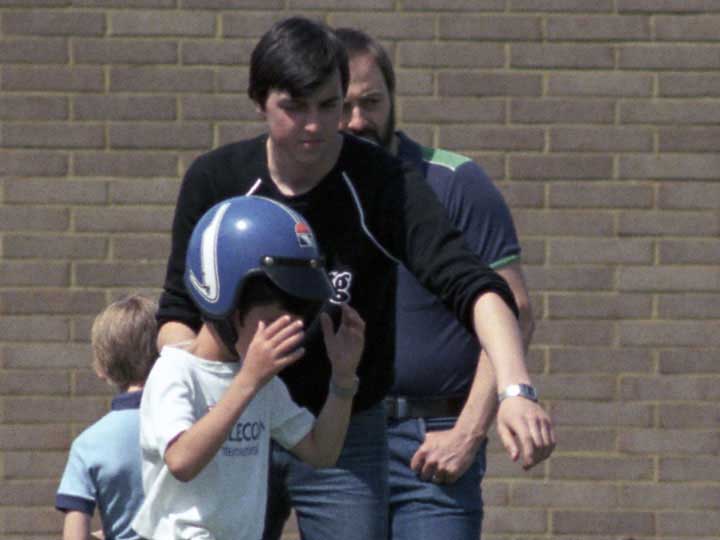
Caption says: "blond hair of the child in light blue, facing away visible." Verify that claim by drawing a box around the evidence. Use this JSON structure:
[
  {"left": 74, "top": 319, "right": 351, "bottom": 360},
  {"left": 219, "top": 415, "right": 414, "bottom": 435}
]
[{"left": 91, "top": 295, "right": 158, "bottom": 391}]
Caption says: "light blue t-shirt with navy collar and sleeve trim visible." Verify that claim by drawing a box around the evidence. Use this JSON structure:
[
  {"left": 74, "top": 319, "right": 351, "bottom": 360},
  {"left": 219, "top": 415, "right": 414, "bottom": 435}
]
[{"left": 55, "top": 392, "right": 143, "bottom": 540}]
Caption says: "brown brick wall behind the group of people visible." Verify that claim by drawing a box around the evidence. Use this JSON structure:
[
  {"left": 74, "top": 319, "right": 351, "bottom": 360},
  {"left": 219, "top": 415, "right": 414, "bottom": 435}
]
[{"left": 0, "top": 0, "right": 720, "bottom": 540}]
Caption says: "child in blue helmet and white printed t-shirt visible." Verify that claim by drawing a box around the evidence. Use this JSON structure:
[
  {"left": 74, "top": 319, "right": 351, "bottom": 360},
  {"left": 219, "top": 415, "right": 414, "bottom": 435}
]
[{"left": 133, "top": 196, "right": 365, "bottom": 540}]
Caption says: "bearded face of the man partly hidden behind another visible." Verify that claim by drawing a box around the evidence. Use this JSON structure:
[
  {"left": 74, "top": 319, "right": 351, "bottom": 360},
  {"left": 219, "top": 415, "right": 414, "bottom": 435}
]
[{"left": 340, "top": 54, "right": 395, "bottom": 148}]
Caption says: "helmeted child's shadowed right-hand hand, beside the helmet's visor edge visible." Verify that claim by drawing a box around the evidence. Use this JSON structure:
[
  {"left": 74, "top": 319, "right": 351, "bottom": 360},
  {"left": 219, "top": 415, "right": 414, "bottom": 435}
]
[{"left": 320, "top": 304, "right": 365, "bottom": 380}]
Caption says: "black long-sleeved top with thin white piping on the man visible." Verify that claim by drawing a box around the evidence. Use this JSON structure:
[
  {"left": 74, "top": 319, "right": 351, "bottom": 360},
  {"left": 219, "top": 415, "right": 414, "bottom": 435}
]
[{"left": 158, "top": 135, "right": 516, "bottom": 413}]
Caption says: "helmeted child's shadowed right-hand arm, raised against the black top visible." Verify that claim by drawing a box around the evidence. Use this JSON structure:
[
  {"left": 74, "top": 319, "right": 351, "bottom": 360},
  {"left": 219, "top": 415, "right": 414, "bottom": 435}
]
[{"left": 292, "top": 304, "right": 365, "bottom": 467}]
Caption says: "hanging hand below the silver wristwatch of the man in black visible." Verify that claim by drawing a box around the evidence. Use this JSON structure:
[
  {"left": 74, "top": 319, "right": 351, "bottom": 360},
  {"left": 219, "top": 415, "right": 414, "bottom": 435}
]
[{"left": 497, "top": 396, "right": 555, "bottom": 470}]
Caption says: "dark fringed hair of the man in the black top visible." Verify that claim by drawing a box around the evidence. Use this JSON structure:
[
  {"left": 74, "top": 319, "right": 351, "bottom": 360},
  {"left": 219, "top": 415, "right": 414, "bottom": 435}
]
[{"left": 248, "top": 17, "right": 350, "bottom": 109}]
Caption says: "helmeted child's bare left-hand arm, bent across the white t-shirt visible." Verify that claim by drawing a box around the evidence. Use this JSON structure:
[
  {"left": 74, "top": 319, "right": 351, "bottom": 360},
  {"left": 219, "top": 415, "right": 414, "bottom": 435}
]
[{"left": 165, "top": 315, "right": 305, "bottom": 482}]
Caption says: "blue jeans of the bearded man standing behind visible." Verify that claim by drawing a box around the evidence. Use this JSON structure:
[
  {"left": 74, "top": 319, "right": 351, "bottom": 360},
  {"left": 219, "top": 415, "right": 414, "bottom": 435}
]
[{"left": 388, "top": 417, "right": 487, "bottom": 540}]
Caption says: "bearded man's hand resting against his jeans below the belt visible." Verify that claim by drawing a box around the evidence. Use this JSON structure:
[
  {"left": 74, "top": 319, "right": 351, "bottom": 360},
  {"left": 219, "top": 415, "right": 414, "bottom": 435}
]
[{"left": 410, "top": 429, "right": 483, "bottom": 484}]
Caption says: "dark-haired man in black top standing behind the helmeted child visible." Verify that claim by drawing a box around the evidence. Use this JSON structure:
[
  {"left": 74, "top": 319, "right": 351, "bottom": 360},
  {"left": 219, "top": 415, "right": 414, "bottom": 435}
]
[{"left": 158, "top": 17, "right": 552, "bottom": 540}]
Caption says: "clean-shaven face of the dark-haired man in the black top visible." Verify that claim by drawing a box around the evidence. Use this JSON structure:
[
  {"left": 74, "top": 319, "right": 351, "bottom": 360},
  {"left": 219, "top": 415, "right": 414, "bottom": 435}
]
[{"left": 261, "top": 72, "right": 342, "bottom": 165}]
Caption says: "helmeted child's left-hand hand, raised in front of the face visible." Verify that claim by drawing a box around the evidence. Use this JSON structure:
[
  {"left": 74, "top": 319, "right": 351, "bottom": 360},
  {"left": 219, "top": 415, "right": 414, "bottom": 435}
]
[{"left": 241, "top": 315, "right": 305, "bottom": 386}]
